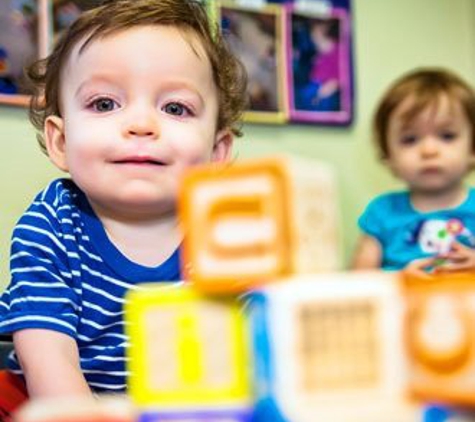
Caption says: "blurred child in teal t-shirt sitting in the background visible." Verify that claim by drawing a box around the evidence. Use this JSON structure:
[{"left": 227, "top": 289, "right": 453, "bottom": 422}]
[{"left": 353, "top": 69, "right": 475, "bottom": 274}]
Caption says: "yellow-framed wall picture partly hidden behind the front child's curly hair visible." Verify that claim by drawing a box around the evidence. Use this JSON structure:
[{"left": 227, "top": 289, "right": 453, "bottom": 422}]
[{"left": 219, "top": 2, "right": 288, "bottom": 123}]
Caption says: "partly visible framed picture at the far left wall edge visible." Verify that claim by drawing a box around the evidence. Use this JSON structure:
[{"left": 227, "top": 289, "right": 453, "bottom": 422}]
[{"left": 0, "top": 0, "right": 48, "bottom": 106}]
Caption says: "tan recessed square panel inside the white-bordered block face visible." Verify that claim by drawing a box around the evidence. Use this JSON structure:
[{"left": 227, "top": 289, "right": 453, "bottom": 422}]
[{"left": 296, "top": 299, "right": 381, "bottom": 394}]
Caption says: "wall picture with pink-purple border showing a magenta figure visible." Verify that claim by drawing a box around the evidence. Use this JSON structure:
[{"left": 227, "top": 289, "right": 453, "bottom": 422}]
[{"left": 286, "top": 3, "right": 353, "bottom": 125}]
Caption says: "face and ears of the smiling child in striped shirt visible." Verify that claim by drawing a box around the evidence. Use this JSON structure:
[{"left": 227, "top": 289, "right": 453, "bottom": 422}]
[{"left": 45, "top": 26, "right": 232, "bottom": 217}]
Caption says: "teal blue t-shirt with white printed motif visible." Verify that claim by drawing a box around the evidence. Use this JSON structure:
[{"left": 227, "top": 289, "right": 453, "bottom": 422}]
[{"left": 358, "top": 189, "right": 475, "bottom": 270}]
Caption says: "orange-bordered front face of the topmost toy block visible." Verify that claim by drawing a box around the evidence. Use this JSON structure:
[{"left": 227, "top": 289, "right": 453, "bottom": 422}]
[{"left": 180, "top": 160, "right": 292, "bottom": 291}]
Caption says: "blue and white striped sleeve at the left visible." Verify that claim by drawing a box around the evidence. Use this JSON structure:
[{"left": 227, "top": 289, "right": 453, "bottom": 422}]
[{"left": 0, "top": 190, "right": 81, "bottom": 338}]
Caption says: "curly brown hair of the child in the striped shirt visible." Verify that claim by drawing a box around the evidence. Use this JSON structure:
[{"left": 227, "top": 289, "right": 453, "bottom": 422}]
[{"left": 26, "top": 0, "right": 247, "bottom": 152}]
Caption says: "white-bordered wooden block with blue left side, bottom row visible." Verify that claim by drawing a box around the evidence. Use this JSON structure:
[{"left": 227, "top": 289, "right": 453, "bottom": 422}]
[{"left": 250, "top": 272, "right": 410, "bottom": 422}]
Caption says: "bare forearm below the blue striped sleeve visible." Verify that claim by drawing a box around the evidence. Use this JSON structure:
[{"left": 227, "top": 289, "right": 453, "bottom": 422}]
[{"left": 13, "top": 329, "right": 92, "bottom": 398}]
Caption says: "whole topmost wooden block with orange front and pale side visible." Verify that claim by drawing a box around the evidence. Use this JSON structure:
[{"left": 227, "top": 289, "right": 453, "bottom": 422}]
[{"left": 179, "top": 157, "right": 339, "bottom": 293}]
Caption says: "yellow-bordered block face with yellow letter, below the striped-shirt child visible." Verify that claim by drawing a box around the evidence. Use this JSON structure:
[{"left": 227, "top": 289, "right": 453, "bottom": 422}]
[{"left": 126, "top": 285, "right": 251, "bottom": 408}]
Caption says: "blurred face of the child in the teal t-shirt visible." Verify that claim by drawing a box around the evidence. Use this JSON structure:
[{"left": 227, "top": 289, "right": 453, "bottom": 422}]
[{"left": 387, "top": 96, "right": 475, "bottom": 194}]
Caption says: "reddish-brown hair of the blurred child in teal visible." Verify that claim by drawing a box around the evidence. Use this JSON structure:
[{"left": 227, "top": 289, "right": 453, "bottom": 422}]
[{"left": 373, "top": 68, "right": 475, "bottom": 159}]
